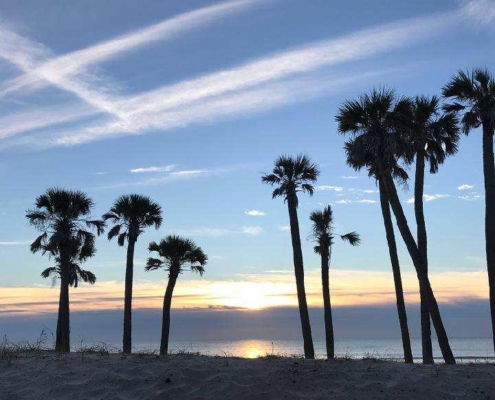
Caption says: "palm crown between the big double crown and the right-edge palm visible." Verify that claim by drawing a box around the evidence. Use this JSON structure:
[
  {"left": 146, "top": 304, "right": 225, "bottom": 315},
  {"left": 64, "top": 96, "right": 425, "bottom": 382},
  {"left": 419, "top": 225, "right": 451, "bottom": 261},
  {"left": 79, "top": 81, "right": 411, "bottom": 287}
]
[{"left": 411, "top": 96, "right": 459, "bottom": 174}]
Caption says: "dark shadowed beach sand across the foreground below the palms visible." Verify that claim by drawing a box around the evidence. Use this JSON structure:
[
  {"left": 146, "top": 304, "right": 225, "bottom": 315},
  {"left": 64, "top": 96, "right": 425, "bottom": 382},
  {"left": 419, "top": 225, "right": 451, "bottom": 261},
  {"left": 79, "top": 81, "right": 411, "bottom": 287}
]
[{"left": 0, "top": 354, "right": 495, "bottom": 400}]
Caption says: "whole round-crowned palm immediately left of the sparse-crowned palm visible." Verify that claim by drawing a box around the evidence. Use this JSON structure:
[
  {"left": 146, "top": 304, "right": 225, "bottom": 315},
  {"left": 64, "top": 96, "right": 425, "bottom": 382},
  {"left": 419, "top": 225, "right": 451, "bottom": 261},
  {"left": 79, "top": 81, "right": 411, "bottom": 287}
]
[{"left": 261, "top": 155, "right": 320, "bottom": 359}]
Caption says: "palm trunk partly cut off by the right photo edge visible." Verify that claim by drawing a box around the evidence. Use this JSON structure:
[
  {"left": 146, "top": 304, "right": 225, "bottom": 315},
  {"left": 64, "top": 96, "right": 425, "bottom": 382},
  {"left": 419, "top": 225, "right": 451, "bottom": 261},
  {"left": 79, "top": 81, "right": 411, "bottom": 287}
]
[{"left": 483, "top": 121, "right": 495, "bottom": 349}]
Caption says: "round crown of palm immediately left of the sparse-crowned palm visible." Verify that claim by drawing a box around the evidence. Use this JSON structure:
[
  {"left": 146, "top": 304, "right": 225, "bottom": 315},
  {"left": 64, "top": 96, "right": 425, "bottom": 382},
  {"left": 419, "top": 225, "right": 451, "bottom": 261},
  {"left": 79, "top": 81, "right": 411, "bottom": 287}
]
[{"left": 261, "top": 155, "right": 320, "bottom": 205}]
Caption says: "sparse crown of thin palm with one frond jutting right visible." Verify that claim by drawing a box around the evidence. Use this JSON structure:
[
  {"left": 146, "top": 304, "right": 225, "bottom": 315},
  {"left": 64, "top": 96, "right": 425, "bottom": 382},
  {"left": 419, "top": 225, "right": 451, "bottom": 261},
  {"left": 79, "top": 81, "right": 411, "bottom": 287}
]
[{"left": 309, "top": 205, "right": 361, "bottom": 254}]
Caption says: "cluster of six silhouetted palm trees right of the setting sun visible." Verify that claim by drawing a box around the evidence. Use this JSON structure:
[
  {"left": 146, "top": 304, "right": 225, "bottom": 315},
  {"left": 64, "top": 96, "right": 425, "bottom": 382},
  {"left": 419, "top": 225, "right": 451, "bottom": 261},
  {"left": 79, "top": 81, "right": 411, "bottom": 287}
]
[{"left": 262, "top": 69, "right": 495, "bottom": 364}]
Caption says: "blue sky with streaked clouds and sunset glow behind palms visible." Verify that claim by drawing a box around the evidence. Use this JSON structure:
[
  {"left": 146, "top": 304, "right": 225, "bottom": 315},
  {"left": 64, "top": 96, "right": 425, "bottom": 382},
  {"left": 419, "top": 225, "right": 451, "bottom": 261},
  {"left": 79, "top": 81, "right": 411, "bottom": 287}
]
[{"left": 0, "top": 0, "right": 495, "bottom": 342}]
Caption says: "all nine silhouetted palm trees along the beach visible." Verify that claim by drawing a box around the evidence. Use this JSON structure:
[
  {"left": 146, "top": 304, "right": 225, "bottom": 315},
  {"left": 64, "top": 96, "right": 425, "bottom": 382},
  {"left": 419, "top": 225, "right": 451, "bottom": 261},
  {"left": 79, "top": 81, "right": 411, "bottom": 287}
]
[{"left": 27, "top": 69, "right": 495, "bottom": 364}]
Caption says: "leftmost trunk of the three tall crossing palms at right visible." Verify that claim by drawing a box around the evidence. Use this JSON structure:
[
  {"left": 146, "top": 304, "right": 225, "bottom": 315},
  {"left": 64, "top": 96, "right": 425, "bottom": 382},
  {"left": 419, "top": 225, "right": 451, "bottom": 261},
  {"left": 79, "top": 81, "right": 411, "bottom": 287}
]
[{"left": 379, "top": 180, "right": 413, "bottom": 363}]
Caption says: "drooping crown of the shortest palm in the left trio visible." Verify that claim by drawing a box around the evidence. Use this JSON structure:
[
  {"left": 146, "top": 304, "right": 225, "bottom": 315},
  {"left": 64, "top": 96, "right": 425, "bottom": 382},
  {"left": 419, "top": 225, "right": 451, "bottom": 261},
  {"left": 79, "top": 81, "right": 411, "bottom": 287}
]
[{"left": 145, "top": 235, "right": 208, "bottom": 276}]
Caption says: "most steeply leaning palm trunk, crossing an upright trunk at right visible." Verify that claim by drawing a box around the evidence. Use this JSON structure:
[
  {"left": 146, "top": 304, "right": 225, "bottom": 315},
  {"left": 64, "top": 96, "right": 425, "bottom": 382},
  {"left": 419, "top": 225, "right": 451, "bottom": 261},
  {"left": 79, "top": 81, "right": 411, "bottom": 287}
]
[{"left": 380, "top": 167, "right": 455, "bottom": 364}]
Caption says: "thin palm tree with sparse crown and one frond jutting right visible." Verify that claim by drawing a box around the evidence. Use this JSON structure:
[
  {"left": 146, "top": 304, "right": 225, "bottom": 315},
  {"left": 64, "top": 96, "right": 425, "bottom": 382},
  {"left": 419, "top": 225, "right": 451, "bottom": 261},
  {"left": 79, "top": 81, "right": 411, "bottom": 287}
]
[{"left": 309, "top": 206, "right": 361, "bottom": 359}]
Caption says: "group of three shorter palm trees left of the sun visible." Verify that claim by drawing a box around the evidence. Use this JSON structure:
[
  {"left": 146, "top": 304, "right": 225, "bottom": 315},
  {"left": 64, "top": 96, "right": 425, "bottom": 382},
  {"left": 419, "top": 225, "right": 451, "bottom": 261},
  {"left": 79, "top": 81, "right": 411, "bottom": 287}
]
[{"left": 26, "top": 188, "right": 208, "bottom": 354}]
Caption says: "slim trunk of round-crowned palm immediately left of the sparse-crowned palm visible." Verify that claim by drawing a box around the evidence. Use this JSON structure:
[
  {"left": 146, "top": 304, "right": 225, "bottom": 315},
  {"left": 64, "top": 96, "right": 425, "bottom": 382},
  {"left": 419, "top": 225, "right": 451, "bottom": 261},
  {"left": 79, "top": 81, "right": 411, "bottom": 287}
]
[{"left": 287, "top": 194, "right": 315, "bottom": 359}]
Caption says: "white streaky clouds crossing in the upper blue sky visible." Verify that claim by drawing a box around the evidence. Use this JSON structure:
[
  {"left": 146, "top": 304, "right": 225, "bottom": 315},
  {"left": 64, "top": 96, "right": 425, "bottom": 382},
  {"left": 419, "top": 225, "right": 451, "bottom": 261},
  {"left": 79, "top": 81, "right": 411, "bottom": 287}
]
[{"left": 0, "top": 0, "right": 472, "bottom": 148}]
